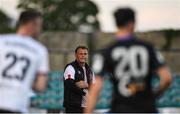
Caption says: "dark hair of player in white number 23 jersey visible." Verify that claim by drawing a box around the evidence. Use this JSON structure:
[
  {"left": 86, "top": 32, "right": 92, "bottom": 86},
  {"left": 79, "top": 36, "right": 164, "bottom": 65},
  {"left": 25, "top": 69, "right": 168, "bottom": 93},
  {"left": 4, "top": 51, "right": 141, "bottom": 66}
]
[{"left": 18, "top": 10, "right": 42, "bottom": 25}]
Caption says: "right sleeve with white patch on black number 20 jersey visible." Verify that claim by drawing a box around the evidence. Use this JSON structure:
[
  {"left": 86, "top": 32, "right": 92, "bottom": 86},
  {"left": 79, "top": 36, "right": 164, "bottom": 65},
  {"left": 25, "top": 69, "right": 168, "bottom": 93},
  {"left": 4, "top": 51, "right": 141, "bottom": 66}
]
[{"left": 150, "top": 48, "right": 165, "bottom": 70}]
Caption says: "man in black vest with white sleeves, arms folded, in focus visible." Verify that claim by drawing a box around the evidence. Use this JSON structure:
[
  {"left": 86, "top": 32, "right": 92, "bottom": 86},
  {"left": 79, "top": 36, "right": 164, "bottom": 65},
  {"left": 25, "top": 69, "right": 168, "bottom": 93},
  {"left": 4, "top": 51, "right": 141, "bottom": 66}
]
[{"left": 63, "top": 46, "right": 95, "bottom": 113}]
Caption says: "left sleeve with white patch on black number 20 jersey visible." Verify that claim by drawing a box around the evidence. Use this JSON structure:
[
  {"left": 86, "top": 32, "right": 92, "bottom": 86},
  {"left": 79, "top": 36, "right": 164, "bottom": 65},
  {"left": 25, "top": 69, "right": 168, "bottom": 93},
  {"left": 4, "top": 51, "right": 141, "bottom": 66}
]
[{"left": 92, "top": 52, "right": 109, "bottom": 77}]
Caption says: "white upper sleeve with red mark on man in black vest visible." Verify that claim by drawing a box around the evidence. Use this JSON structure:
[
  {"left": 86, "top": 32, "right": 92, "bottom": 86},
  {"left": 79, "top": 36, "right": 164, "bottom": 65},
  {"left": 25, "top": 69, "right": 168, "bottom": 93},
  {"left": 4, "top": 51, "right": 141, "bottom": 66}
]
[{"left": 64, "top": 65, "right": 75, "bottom": 80}]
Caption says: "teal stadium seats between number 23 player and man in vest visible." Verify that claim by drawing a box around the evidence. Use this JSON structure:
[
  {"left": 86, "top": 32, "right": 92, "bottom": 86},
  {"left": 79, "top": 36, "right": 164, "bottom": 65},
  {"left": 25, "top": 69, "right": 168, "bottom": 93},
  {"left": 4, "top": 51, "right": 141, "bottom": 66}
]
[{"left": 31, "top": 72, "right": 64, "bottom": 109}]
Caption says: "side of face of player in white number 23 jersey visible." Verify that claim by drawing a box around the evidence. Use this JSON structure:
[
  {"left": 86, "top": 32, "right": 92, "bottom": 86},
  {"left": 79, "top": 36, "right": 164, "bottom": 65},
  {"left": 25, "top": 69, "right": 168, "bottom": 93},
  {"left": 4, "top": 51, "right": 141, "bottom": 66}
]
[{"left": 28, "top": 17, "right": 42, "bottom": 38}]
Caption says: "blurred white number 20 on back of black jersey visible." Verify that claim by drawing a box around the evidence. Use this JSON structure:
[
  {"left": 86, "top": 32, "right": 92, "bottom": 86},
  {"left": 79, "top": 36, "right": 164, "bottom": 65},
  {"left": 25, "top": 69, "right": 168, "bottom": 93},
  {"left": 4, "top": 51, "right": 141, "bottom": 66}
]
[{"left": 112, "top": 46, "right": 148, "bottom": 97}]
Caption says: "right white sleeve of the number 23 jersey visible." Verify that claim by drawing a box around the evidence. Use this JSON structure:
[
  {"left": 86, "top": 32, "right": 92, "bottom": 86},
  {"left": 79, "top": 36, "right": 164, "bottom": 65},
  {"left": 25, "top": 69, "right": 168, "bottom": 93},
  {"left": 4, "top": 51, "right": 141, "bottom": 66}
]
[{"left": 37, "top": 49, "right": 49, "bottom": 73}]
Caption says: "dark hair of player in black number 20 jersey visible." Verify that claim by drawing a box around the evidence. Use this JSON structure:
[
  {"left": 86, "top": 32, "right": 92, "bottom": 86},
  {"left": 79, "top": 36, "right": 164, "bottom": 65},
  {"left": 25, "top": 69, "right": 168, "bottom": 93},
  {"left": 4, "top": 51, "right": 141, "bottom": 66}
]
[{"left": 114, "top": 8, "right": 135, "bottom": 27}]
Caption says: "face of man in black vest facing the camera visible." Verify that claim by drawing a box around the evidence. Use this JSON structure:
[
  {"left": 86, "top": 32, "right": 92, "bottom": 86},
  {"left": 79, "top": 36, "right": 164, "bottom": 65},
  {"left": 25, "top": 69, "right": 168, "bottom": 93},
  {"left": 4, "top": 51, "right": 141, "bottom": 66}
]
[{"left": 76, "top": 48, "right": 88, "bottom": 63}]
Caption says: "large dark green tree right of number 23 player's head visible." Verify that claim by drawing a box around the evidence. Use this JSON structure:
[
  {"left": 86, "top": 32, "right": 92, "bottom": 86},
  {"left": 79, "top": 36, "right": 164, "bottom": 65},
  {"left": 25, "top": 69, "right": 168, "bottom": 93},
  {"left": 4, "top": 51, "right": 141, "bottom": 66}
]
[{"left": 17, "top": 0, "right": 99, "bottom": 31}]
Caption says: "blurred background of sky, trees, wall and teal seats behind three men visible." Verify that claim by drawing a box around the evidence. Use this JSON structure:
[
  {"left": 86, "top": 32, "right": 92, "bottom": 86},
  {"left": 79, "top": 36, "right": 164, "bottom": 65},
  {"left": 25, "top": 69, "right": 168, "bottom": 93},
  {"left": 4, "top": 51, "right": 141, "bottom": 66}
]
[{"left": 0, "top": 0, "right": 180, "bottom": 113}]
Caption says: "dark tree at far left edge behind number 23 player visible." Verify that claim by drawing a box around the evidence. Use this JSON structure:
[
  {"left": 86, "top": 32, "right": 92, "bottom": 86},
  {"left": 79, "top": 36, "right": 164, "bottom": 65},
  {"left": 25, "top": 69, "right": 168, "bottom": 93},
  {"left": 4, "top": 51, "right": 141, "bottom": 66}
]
[{"left": 0, "top": 10, "right": 12, "bottom": 33}]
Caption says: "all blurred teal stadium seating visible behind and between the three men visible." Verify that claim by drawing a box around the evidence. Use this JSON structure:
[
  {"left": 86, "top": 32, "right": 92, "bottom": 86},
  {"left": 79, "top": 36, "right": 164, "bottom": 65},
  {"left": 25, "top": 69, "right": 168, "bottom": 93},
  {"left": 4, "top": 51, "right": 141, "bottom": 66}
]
[{"left": 31, "top": 72, "right": 180, "bottom": 110}]
